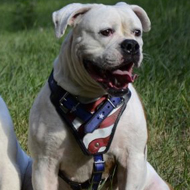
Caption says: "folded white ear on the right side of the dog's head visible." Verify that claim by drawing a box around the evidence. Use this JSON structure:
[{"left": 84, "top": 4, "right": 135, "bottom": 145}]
[{"left": 130, "top": 5, "right": 151, "bottom": 32}]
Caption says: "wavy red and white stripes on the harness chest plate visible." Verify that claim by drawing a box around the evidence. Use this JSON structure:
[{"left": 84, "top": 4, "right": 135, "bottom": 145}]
[{"left": 64, "top": 97, "right": 123, "bottom": 154}]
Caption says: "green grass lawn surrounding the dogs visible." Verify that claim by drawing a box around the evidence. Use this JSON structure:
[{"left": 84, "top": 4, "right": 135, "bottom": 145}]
[{"left": 0, "top": 0, "right": 190, "bottom": 190}]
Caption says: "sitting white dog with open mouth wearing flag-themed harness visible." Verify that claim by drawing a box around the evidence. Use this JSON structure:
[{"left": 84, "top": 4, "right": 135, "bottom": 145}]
[{"left": 29, "top": 3, "right": 173, "bottom": 190}]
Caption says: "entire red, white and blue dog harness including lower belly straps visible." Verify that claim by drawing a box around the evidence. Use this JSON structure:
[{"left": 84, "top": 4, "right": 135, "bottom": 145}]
[{"left": 48, "top": 71, "right": 131, "bottom": 190}]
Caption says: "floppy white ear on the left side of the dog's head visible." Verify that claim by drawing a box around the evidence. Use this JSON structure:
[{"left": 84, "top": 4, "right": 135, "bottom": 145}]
[{"left": 52, "top": 3, "right": 92, "bottom": 38}]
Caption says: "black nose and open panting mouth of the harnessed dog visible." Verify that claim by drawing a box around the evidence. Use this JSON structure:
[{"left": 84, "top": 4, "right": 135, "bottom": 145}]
[{"left": 83, "top": 39, "right": 140, "bottom": 96}]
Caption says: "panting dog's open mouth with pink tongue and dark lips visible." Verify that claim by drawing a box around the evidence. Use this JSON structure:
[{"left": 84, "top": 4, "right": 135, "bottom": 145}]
[{"left": 84, "top": 61, "right": 137, "bottom": 94}]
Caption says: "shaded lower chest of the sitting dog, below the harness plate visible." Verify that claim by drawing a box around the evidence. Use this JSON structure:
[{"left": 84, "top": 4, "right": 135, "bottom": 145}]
[{"left": 60, "top": 141, "right": 116, "bottom": 182}]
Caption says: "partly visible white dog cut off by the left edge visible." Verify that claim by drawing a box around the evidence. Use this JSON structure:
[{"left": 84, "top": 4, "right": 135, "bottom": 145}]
[{"left": 0, "top": 97, "right": 32, "bottom": 190}]
